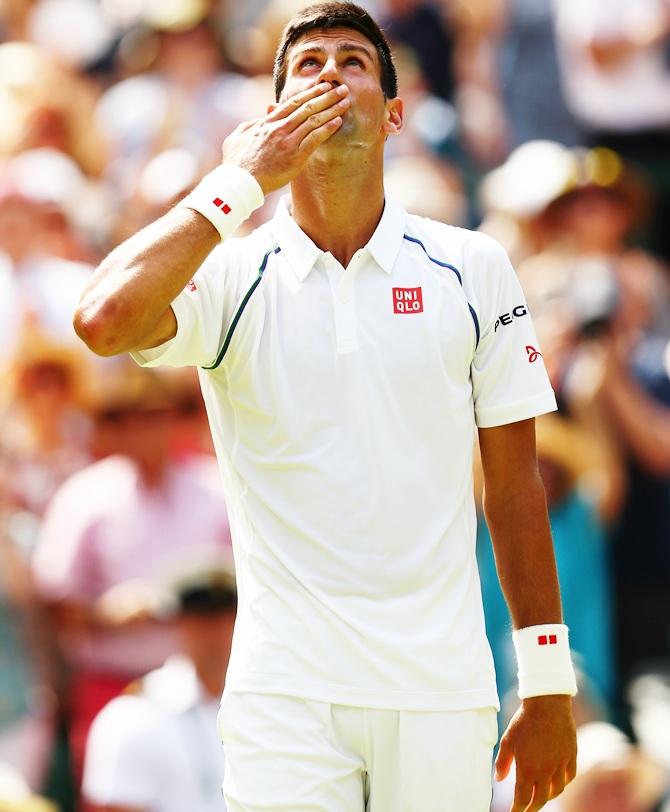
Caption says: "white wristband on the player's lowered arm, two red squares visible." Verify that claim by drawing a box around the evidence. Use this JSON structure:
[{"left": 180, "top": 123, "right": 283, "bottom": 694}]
[{"left": 512, "top": 623, "right": 577, "bottom": 699}]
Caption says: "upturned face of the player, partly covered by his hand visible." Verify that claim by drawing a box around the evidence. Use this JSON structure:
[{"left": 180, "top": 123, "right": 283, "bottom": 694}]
[{"left": 280, "top": 28, "right": 402, "bottom": 149}]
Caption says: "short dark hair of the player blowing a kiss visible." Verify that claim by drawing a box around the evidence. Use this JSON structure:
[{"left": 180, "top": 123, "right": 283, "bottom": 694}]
[{"left": 273, "top": 2, "right": 398, "bottom": 101}]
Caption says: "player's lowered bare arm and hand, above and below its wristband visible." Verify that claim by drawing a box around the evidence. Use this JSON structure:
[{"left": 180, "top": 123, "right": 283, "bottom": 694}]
[{"left": 479, "top": 419, "right": 576, "bottom": 812}]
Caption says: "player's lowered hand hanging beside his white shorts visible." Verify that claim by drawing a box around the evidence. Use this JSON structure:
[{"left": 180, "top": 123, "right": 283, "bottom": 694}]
[{"left": 496, "top": 695, "right": 577, "bottom": 812}]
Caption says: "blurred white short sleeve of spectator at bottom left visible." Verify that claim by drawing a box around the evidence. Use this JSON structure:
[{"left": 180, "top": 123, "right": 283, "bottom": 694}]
[{"left": 82, "top": 696, "right": 163, "bottom": 809}]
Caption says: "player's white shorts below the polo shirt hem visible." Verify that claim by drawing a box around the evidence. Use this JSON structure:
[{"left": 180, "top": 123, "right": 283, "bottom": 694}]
[{"left": 219, "top": 693, "right": 498, "bottom": 812}]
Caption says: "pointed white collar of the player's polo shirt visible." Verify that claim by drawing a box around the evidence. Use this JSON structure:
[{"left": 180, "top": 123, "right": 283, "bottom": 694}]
[{"left": 272, "top": 195, "right": 407, "bottom": 282}]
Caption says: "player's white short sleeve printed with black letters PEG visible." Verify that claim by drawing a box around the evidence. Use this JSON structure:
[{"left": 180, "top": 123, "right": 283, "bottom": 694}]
[{"left": 463, "top": 234, "right": 556, "bottom": 428}]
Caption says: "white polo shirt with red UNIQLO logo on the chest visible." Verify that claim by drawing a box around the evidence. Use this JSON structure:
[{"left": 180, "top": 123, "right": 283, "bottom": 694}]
[{"left": 135, "top": 199, "right": 555, "bottom": 710}]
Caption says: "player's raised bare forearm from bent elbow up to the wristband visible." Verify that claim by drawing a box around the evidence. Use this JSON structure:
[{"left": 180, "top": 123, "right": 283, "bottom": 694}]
[{"left": 74, "top": 207, "right": 220, "bottom": 355}]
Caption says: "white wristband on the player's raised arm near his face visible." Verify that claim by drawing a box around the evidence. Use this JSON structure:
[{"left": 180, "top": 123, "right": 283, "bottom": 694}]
[{"left": 177, "top": 164, "right": 265, "bottom": 240}]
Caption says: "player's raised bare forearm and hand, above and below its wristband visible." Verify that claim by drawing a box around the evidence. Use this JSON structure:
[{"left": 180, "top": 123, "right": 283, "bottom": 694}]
[{"left": 74, "top": 83, "right": 349, "bottom": 355}]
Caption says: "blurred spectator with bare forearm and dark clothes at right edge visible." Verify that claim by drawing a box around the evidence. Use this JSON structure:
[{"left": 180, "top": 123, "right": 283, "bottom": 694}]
[{"left": 599, "top": 336, "right": 670, "bottom": 696}]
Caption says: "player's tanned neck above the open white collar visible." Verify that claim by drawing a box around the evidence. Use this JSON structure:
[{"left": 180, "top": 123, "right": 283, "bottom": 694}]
[{"left": 291, "top": 151, "right": 384, "bottom": 268}]
